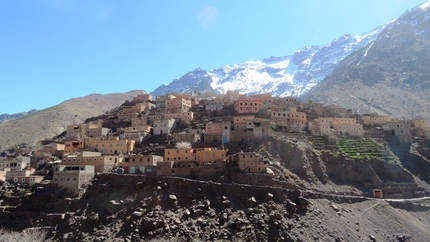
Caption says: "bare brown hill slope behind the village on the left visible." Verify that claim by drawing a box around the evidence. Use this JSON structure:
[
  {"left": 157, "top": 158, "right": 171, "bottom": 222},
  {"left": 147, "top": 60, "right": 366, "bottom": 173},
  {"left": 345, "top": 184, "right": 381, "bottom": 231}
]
[{"left": 0, "top": 90, "right": 142, "bottom": 150}]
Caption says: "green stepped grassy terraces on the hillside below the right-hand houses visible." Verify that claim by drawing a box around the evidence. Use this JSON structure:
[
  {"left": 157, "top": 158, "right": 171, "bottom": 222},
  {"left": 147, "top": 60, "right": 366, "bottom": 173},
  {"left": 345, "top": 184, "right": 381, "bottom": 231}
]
[{"left": 336, "top": 138, "right": 395, "bottom": 162}]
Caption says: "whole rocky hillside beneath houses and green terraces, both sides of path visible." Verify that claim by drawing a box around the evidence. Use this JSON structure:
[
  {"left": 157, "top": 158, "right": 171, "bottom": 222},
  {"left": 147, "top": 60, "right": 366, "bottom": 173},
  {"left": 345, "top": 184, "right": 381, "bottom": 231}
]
[{"left": 0, "top": 136, "right": 430, "bottom": 241}]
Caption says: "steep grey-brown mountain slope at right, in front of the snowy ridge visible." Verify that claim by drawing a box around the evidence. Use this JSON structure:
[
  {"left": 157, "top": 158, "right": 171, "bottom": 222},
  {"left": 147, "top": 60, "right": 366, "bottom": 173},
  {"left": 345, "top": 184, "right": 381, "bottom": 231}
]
[{"left": 302, "top": 3, "right": 430, "bottom": 120}]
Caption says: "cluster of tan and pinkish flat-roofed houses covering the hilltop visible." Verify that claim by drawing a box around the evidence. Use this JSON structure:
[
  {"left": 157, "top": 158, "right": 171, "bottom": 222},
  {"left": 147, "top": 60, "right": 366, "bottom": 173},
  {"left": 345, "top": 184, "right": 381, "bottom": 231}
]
[{"left": 0, "top": 91, "right": 430, "bottom": 191}]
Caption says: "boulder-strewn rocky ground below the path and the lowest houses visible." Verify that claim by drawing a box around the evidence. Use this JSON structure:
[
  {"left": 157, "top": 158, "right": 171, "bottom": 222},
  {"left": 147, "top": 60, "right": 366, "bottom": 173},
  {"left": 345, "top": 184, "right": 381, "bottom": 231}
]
[{"left": 0, "top": 174, "right": 430, "bottom": 241}]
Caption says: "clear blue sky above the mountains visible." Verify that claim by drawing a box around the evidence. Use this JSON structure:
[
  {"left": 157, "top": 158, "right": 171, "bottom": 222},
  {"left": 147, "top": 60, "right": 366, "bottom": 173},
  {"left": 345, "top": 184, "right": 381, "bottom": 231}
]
[{"left": 0, "top": 0, "right": 424, "bottom": 114}]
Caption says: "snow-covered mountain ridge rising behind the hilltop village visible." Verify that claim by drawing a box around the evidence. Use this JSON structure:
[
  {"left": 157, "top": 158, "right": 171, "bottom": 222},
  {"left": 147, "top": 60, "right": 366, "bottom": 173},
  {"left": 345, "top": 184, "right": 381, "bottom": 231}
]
[{"left": 151, "top": 26, "right": 384, "bottom": 96}]
